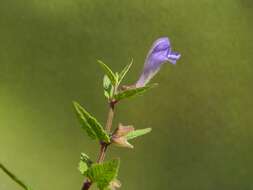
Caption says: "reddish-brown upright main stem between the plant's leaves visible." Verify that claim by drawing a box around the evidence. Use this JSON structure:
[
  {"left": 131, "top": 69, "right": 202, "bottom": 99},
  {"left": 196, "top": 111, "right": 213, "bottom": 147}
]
[{"left": 82, "top": 102, "right": 115, "bottom": 190}]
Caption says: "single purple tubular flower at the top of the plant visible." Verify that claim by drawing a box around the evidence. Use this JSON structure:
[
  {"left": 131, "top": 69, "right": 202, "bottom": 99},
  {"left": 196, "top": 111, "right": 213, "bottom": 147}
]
[{"left": 136, "top": 37, "right": 181, "bottom": 87}]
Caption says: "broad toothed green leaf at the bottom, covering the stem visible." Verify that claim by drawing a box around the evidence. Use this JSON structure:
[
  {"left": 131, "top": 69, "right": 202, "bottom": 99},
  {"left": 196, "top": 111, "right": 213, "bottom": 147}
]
[{"left": 86, "top": 159, "right": 120, "bottom": 190}]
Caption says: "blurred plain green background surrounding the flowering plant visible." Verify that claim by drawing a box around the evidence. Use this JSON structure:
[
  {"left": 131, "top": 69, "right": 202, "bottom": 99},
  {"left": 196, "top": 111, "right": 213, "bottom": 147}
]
[{"left": 0, "top": 0, "right": 253, "bottom": 190}]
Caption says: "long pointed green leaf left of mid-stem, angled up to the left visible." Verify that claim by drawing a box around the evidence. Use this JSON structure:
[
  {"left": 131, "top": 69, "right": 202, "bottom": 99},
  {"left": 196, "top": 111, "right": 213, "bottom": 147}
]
[{"left": 73, "top": 102, "right": 110, "bottom": 143}]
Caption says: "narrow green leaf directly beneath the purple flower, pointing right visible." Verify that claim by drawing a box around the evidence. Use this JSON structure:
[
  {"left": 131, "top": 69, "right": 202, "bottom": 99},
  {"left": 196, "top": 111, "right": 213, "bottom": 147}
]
[{"left": 114, "top": 84, "right": 156, "bottom": 101}]
